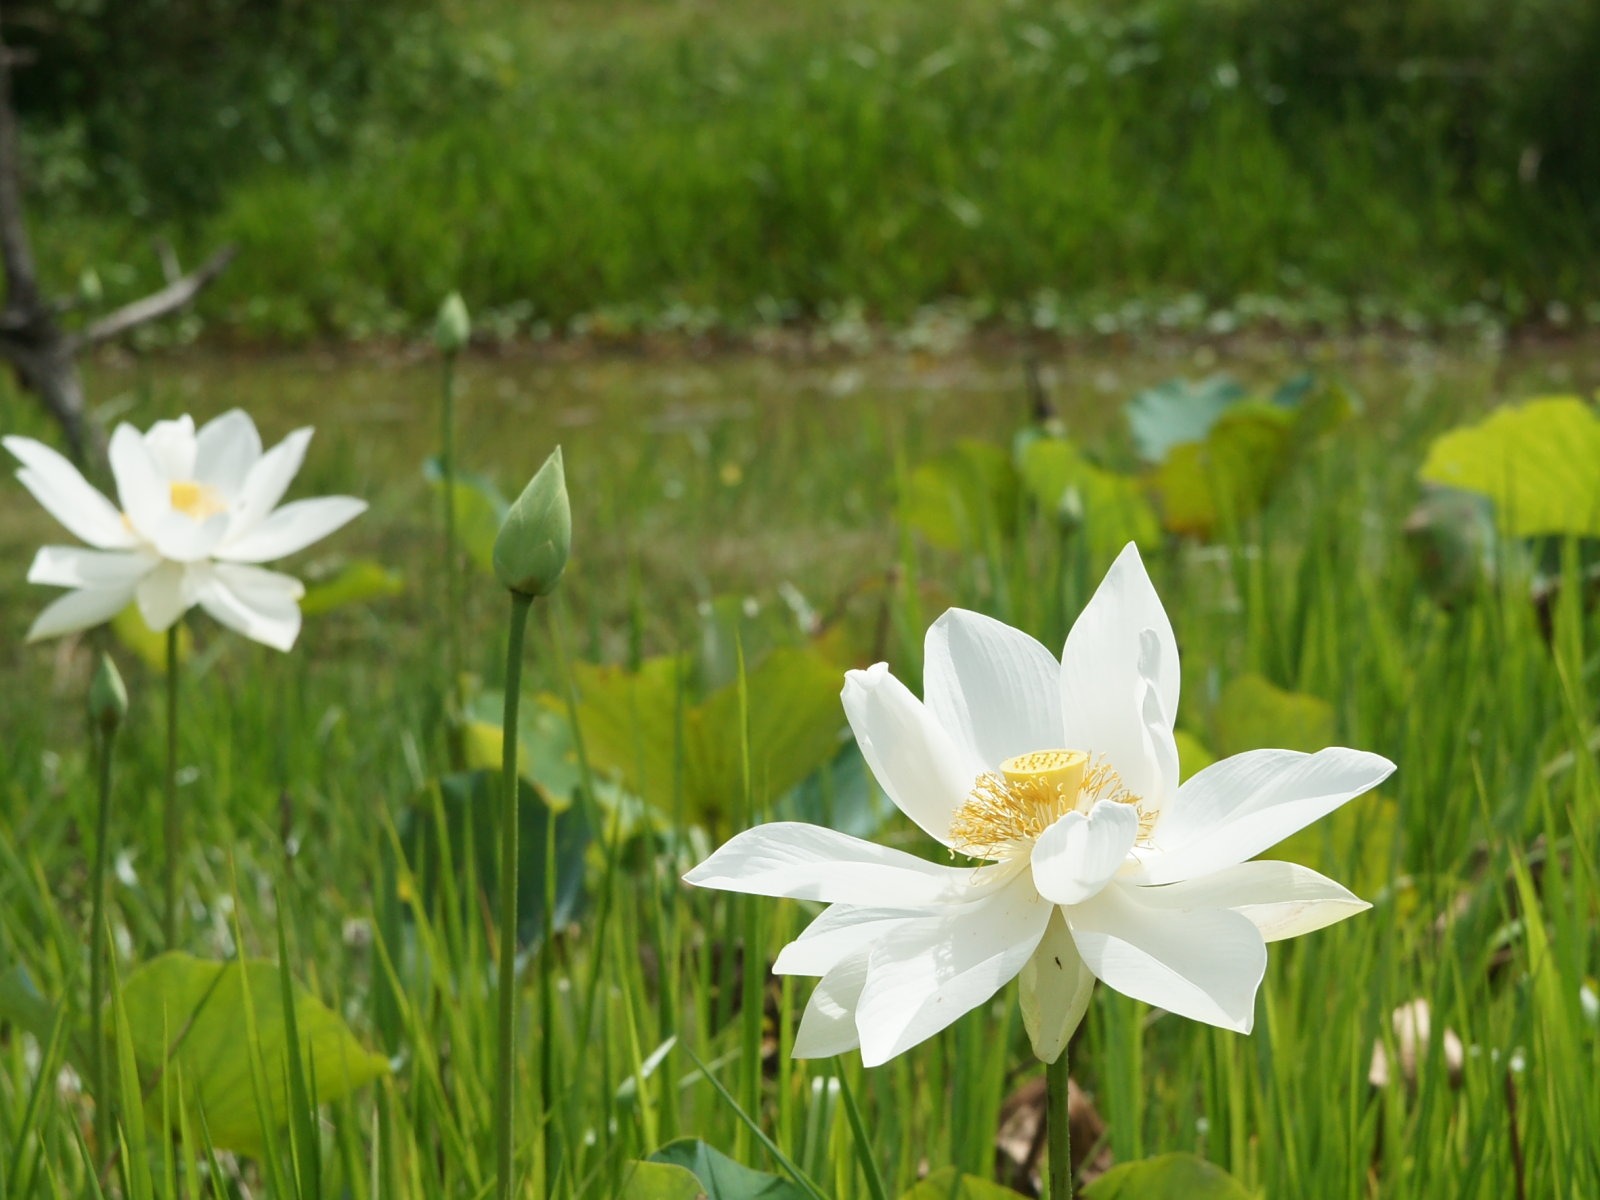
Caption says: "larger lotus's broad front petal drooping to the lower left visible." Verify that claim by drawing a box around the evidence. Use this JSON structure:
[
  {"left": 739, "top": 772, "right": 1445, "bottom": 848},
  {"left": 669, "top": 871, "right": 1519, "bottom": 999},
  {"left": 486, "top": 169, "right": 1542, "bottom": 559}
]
[{"left": 856, "top": 872, "right": 1053, "bottom": 1067}]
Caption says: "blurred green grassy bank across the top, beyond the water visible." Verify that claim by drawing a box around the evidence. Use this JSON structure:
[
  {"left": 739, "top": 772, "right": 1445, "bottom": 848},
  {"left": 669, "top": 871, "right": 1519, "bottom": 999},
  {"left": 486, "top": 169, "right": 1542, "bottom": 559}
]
[{"left": 18, "top": 0, "right": 1600, "bottom": 339}]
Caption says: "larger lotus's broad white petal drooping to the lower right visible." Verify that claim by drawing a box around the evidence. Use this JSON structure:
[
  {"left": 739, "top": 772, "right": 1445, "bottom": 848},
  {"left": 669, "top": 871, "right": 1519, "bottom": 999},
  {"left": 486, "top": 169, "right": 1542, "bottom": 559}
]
[{"left": 1067, "top": 882, "right": 1267, "bottom": 1034}]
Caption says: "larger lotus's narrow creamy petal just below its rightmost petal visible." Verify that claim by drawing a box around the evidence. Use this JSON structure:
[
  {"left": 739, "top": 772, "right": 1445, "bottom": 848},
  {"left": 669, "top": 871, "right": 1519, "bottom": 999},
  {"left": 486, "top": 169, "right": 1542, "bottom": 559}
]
[{"left": 1139, "top": 859, "right": 1373, "bottom": 942}]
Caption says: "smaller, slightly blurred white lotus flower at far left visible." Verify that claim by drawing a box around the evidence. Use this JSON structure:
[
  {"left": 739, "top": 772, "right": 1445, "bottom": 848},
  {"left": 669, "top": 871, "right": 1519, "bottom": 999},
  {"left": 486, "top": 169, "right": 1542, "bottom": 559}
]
[{"left": 3, "top": 410, "right": 366, "bottom": 650}]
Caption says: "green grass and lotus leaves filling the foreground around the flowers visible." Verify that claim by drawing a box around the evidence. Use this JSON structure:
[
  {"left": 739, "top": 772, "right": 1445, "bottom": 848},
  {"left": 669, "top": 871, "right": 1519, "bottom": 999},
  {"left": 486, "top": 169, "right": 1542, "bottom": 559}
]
[{"left": 0, "top": 345, "right": 1600, "bottom": 1200}]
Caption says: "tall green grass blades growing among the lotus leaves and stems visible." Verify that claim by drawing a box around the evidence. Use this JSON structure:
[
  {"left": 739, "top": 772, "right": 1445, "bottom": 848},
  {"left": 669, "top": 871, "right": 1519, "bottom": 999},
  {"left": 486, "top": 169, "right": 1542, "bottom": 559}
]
[{"left": 0, "top": 342, "right": 1600, "bottom": 1200}]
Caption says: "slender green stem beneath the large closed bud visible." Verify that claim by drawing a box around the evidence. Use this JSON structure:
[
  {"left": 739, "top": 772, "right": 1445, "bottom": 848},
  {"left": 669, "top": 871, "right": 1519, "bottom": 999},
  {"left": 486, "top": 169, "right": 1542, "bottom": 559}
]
[{"left": 494, "top": 592, "right": 533, "bottom": 1200}]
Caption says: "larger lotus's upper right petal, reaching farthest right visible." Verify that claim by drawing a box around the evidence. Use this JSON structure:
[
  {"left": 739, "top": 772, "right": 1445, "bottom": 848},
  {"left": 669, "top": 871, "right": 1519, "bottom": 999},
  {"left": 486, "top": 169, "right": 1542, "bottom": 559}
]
[{"left": 1138, "top": 746, "right": 1395, "bottom": 883}]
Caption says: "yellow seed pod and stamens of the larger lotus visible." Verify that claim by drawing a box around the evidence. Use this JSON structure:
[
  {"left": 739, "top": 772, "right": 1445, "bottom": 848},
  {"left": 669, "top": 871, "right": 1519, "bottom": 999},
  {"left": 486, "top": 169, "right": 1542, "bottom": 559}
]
[{"left": 950, "top": 750, "right": 1146, "bottom": 861}]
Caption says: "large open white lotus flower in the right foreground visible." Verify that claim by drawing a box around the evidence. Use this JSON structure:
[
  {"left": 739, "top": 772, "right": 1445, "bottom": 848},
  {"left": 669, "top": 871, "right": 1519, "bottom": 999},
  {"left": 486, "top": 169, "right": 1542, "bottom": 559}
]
[{"left": 685, "top": 546, "right": 1394, "bottom": 1066}]
